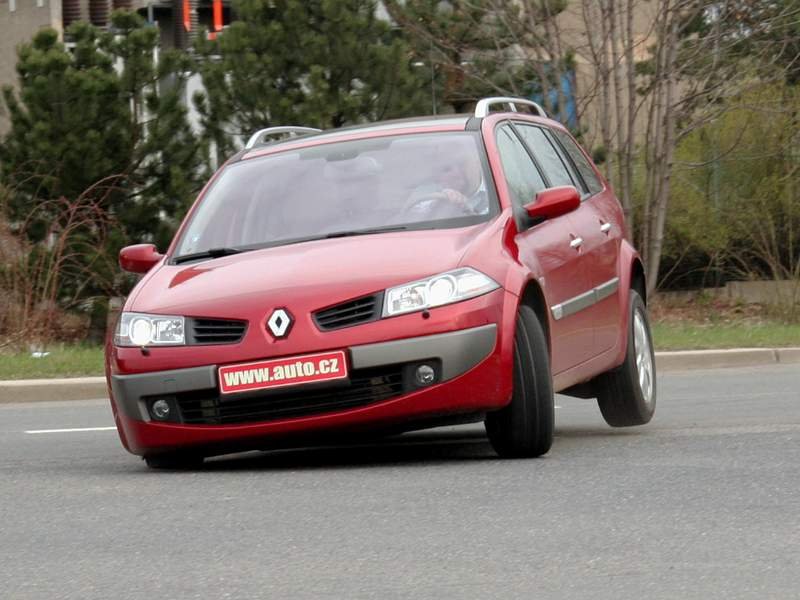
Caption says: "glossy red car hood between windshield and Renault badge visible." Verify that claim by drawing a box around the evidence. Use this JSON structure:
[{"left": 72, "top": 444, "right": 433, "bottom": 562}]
[{"left": 126, "top": 224, "right": 486, "bottom": 318}]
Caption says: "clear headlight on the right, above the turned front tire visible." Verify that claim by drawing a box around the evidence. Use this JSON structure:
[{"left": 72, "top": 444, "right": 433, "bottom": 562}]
[{"left": 383, "top": 267, "right": 500, "bottom": 317}]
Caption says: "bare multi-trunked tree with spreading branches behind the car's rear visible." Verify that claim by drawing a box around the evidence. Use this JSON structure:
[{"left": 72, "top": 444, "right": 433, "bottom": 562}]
[{"left": 370, "top": 0, "right": 800, "bottom": 292}]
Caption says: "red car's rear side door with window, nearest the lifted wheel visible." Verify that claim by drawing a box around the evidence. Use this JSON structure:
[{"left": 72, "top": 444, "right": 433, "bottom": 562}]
[{"left": 547, "top": 128, "right": 625, "bottom": 353}]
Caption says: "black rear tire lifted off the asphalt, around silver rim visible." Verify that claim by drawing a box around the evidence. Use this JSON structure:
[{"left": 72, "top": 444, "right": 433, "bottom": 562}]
[{"left": 595, "top": 290, "right": 656, "bottom": 427}]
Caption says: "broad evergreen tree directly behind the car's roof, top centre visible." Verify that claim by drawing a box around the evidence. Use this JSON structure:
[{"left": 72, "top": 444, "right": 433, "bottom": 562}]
[{"left": 195, "top": 0, "right": 429, "bottom": 153}]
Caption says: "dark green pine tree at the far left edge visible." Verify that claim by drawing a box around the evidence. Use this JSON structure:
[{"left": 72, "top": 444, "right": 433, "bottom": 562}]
[{"left": 0, "top": 23, "right": 131, "bottom": 230}]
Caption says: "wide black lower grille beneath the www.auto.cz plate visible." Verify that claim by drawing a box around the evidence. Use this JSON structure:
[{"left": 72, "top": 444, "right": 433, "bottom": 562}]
[{"left": 175, "top": 365, "right": 405, "bottom": 425}]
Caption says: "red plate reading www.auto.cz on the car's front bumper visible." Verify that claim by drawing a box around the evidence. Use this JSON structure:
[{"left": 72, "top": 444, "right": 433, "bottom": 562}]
[{"left": 219, "top": 350, "right": 347, "bottom": 394}]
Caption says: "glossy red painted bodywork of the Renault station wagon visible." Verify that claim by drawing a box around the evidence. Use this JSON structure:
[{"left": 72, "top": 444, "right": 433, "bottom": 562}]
[{"left": 107, "top": 113, "right": 639, "bottom": 455}]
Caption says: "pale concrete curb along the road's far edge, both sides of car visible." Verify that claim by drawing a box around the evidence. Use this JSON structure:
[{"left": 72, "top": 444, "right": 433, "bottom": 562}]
[{"left": 0, "top": 347, "right": 800, "bottom": 404}]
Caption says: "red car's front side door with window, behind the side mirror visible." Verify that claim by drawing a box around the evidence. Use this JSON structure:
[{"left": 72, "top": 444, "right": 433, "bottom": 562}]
[{"left": 495, "top": 123, "right": 593, "bottom": 374}]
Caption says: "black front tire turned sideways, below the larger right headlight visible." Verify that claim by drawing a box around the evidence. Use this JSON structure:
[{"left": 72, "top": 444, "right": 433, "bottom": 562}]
[{"left": 485, "top": 306, "right": 555, "bottom": 458}]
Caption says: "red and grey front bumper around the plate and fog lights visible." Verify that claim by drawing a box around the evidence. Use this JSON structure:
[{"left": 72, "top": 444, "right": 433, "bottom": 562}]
[{"left": 110, "top": 323, "right": 510, "bottom": 454}]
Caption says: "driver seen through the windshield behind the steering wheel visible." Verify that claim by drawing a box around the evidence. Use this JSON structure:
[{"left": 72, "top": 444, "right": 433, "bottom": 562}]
[{"left": 407, "top": 139, "right": 489, "bottom": 217}]
